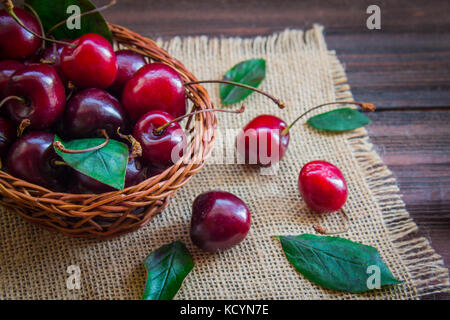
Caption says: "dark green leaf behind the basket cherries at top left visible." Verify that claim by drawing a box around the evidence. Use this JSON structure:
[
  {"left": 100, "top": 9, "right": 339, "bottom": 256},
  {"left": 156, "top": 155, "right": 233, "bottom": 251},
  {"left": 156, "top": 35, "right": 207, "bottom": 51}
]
[{"left": 25, "top": 0, "right": 113, "bottom": 43}]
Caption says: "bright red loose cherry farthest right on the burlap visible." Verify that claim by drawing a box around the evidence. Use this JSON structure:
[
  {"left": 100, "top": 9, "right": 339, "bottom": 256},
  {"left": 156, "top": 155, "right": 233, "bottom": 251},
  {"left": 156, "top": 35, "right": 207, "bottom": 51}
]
[{"left": 298, "top": 161, "right": 347, "bottom": 213}]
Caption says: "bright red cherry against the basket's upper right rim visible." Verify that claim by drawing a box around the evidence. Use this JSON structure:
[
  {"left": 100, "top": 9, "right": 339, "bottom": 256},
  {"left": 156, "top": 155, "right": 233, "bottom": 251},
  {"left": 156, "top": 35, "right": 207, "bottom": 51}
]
[{"left": 122, "top": 62, "right": 186, "bottom": 121}]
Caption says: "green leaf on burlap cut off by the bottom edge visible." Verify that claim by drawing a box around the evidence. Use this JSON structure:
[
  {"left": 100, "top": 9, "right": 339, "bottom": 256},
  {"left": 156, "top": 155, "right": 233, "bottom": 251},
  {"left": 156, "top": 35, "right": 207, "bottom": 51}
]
[{"left": 142, "top": 241, "right": 194, "bottom": 300}]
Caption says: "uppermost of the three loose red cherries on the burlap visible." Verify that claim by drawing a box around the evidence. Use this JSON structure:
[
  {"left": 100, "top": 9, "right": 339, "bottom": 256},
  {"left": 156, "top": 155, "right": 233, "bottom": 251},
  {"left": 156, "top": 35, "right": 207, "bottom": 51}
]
[{"left": 236, "top": 114, "right": 289, "bottom": 166}]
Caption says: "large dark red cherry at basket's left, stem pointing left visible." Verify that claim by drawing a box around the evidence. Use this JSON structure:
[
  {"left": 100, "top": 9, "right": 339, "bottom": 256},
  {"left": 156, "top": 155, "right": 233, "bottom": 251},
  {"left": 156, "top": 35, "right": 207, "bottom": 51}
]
[{"left": 5, "top": 64, "right": 66, "bottom": 129}]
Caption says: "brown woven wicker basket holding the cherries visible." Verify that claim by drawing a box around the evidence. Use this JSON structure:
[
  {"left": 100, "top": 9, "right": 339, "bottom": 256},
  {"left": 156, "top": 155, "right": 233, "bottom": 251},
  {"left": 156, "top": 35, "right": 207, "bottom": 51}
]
[{"left": 0, "top": 24, "right": 217, "bottom": 238}]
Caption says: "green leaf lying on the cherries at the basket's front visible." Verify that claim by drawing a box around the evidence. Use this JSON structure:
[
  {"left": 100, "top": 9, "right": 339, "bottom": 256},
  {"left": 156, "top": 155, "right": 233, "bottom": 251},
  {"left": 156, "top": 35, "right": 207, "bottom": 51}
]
[{"left": 55, "top": 136, "right": 128, "bottom": 190}]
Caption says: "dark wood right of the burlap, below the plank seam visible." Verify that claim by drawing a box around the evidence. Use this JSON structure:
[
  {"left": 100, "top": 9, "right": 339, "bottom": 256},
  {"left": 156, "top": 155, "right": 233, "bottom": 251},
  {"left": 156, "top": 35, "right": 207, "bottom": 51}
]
[{"left": 368, "top": 109, "right": 450, "bottom": 299}]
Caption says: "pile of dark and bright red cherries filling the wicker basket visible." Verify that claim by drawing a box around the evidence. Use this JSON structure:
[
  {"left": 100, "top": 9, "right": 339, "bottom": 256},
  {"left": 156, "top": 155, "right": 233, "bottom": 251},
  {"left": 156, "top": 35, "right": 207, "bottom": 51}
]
[{"left": 0, "top": 8, "right": 186, "bottom": 193}]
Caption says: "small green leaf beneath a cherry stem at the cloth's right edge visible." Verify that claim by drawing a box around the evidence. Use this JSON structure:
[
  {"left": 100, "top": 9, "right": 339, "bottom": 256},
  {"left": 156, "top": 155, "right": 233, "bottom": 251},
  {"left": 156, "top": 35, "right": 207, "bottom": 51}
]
[{"left": 308, "top": 108, "right": 370, "bottom": 132}]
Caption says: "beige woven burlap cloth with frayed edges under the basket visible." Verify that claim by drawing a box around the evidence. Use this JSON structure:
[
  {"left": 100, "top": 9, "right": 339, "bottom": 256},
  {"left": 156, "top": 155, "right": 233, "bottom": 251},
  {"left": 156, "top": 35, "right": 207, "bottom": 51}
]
[{"left": 0, "top": 26, "right": 448, "bottom": 299}]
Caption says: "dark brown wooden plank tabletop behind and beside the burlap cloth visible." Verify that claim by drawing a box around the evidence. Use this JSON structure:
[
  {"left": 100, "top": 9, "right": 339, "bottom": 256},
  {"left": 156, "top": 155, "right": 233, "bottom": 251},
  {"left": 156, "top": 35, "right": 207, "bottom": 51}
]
[{"left": 103, "top": 0, "right": 450, "bottom": 299}]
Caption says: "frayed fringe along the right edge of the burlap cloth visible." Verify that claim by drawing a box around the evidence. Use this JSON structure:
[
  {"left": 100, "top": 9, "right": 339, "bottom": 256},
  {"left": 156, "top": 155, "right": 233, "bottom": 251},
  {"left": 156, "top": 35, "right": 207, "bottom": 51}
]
[{"left": 314, "top": 25, "right": 449, "bottom": 298}]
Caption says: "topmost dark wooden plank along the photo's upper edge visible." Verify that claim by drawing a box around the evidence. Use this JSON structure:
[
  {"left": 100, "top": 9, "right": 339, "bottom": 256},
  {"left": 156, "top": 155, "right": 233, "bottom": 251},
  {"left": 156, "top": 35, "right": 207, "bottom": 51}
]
[{"left": 102, "top": 0, "right": 450, "bottom": 36}]
